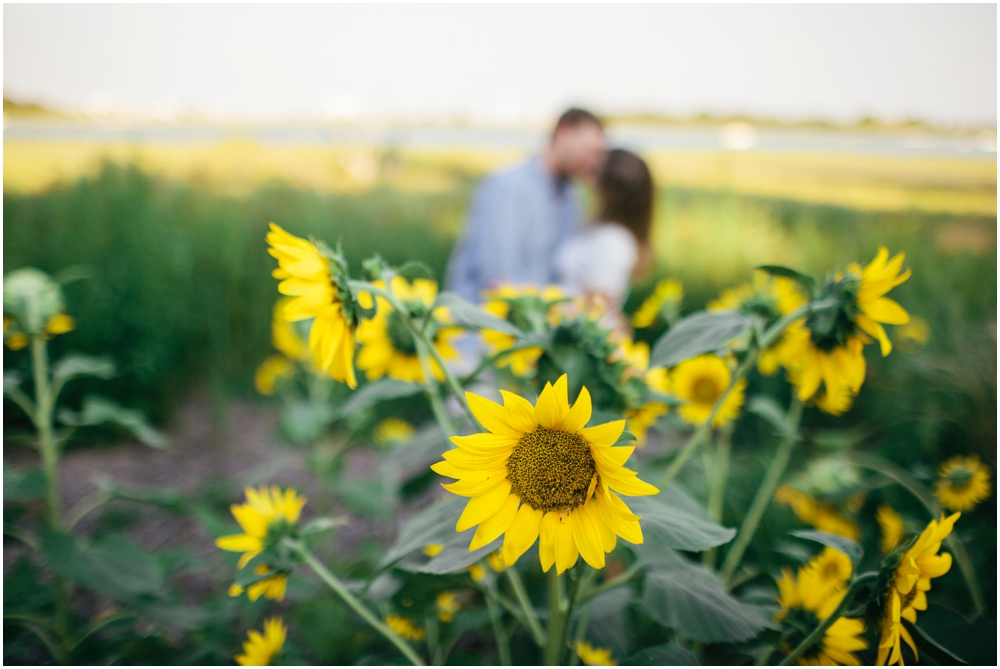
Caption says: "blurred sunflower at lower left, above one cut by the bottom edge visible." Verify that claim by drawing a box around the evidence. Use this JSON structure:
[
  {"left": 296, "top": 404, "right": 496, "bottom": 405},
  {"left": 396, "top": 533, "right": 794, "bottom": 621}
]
[{"left": 215, "top": 486, "right": 306, "bottom": 600}]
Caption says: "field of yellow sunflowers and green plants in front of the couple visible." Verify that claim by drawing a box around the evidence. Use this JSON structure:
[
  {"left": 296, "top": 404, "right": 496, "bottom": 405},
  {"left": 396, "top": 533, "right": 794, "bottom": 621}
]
[{"left": 4, "top": 155, "right": 996, "bottom": 666}]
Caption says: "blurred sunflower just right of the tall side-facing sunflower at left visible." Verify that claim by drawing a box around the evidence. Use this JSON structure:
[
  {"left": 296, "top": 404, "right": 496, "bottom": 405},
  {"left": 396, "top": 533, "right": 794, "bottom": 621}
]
[{"left": 358, "top": 274, "right": 462, "bottom": 383}]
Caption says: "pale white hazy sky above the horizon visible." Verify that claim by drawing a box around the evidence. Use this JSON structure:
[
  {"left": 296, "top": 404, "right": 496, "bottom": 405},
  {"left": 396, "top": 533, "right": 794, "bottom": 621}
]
[{"left": 3, "top": 4, "right": 997, "bottom": 126}]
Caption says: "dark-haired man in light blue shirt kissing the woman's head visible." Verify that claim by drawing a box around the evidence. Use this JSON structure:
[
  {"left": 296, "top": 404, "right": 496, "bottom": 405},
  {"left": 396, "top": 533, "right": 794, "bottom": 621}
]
[{"left": 446, "top": 109, "right": 607, "bottom": 303}]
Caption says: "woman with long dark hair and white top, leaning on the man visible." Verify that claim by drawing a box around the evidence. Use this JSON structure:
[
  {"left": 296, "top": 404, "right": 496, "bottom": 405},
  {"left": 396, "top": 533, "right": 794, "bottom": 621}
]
[{"left": 555, "top": 149, "right": 653, "bottom": 314}]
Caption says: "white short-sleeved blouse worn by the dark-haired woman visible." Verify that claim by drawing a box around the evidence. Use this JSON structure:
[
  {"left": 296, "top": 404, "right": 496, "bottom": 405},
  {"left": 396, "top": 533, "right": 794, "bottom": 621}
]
[{"left": 555, "top": 223, "right": 639, "bottom": 308}]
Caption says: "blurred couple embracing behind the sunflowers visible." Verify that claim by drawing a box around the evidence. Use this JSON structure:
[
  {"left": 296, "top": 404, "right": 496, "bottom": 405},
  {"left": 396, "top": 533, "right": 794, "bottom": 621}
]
[{"left": 447, "top": 109, "right": 653, "bottom": 322}]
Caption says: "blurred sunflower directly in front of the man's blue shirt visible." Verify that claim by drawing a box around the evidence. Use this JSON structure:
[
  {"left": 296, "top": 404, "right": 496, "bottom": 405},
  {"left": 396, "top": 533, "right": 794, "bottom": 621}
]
[{"left": 482, "top": 285, "right": 566, "bottom": 378}]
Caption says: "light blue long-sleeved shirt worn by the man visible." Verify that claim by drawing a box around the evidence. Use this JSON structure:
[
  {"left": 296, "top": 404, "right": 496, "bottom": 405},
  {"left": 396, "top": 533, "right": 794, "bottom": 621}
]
[{"left": 445, "top": 157, "right": 582, "bottom": 303}]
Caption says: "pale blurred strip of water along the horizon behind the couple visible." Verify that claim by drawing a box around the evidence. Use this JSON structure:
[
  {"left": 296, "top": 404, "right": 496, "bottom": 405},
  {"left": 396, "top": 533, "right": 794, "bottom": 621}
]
[{"left": 3, "top": 120, "right": 996, "bottom": 161}]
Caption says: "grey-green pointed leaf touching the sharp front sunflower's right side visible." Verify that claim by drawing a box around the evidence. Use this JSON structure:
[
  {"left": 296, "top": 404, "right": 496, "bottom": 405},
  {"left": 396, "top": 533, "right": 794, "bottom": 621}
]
[{"left": 627, "top": 494, "right": 736, "bottom": 559}]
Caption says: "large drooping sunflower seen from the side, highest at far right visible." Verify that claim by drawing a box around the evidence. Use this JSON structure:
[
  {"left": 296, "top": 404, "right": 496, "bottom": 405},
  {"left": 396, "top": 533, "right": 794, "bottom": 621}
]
[{"left": 782, "top": 246, "right": 910, "bottom": 412}]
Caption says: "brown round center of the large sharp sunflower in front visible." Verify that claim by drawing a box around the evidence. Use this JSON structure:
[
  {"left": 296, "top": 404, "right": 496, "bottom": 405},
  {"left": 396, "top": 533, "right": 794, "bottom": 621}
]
[{"left": 507, "top": 426, "right": 597, "bottom": 511}]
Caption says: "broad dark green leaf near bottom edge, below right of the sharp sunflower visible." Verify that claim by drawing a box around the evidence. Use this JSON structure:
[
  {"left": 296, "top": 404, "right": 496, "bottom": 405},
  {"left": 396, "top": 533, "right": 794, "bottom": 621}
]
[{"left": 642, "top": 551, "right": 772, "bottom": 643}]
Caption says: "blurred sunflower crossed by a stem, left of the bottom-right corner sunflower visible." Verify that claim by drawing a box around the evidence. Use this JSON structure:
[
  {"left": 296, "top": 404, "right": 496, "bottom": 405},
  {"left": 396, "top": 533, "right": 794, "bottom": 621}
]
[{"left": 774, "top": 551, "right": 868, "bottom": 666}]
